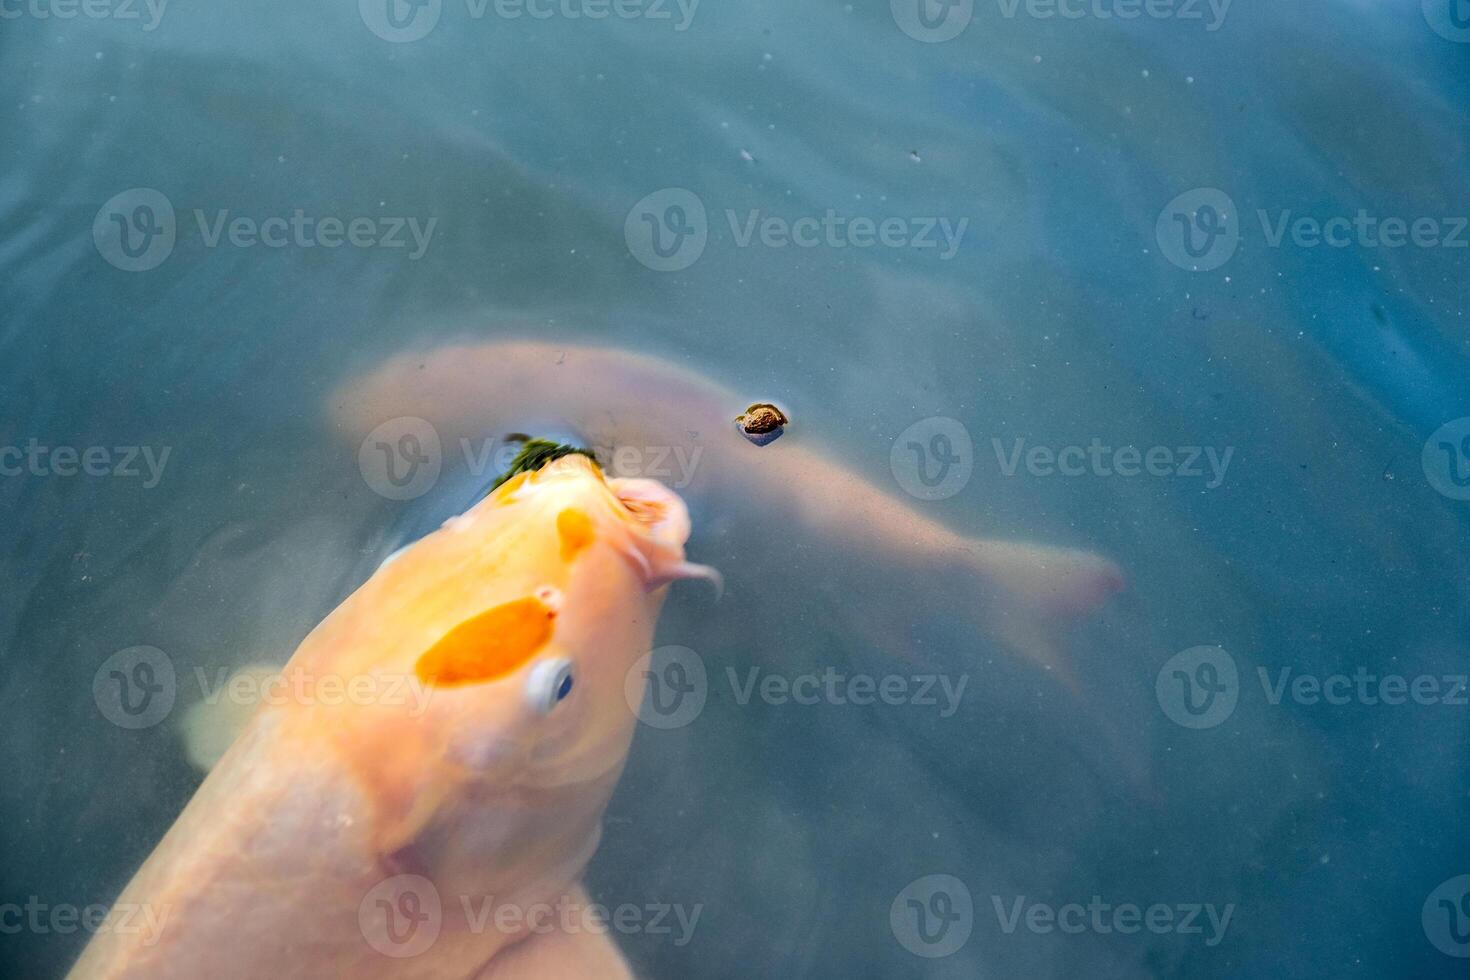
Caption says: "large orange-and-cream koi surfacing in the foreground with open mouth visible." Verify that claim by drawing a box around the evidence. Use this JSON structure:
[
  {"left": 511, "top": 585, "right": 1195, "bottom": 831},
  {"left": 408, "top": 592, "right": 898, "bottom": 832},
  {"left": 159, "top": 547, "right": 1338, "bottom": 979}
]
[{"left": 72, "top": 455, "right": 711, "bottom": 980}]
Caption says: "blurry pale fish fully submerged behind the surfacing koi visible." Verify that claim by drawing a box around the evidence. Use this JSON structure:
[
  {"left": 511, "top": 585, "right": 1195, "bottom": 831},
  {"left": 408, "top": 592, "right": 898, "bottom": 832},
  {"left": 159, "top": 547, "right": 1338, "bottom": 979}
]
[{"left": 328, "top": 340, "right": 1125, "bottom": 691}]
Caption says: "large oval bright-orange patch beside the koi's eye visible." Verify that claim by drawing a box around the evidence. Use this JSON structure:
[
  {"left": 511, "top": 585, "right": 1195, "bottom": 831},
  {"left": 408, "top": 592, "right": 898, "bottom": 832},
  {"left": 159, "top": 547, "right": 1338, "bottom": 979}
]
[{"left": 413, "top": 595, "right": 556, "bottom": 688}]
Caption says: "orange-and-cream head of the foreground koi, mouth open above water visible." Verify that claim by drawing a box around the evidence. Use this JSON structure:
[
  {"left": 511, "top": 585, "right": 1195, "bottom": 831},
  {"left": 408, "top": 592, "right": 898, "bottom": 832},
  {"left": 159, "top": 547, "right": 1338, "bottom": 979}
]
[{"left": 295, "top": 455, "right": 717, "bottom": 864}]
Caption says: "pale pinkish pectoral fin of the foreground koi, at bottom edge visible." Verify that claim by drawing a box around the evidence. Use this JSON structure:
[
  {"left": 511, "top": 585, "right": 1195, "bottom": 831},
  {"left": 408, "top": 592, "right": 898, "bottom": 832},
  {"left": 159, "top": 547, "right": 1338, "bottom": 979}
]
[{"left": 472, "top": 884, "right": 634, "bottom": 980}]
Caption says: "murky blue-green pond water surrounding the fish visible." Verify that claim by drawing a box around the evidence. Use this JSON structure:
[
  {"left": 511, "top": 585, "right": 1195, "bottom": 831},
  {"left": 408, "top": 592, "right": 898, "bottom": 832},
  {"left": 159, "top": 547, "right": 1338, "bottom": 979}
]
[{"left": 0, "top": 0, "right": 1470, "bottom": 980}]
